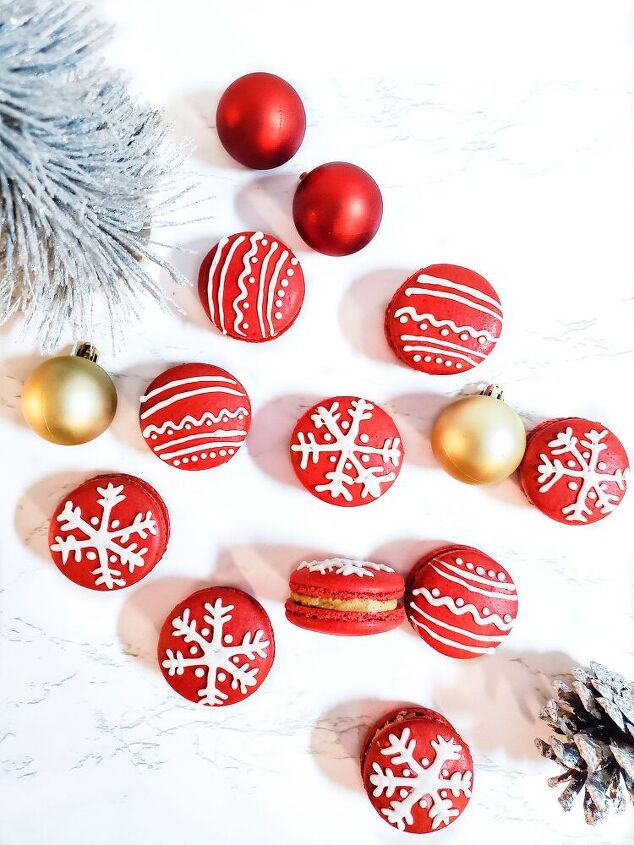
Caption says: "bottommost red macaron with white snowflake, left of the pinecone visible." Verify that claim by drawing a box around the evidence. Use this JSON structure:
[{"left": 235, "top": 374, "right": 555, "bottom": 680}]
[{"left": 361, "top": 706, "right": 473, "bottom": 833}]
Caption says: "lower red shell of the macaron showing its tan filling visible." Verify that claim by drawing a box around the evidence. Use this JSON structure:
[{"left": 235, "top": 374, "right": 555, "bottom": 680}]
[{"left": 285, "top": 599, "right": 405, "bottom": 637}]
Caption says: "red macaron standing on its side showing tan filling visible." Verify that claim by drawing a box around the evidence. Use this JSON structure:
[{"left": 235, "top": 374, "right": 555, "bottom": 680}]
[{"left": 286, "top": 558, "right": 405, "bottom": 636}]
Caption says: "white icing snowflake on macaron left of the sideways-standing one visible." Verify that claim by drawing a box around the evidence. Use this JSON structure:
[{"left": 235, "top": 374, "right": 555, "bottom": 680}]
[{"left": 162, "top": 599, "right": 270, "bottom": 706}]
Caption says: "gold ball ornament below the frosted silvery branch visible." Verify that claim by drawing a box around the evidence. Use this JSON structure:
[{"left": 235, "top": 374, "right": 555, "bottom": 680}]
[{"left": 22, "top": 343, "right": 117, "bottom": 446}]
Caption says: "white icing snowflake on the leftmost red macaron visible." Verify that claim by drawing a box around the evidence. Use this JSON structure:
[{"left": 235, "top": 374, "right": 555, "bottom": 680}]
[{"left": 51, "top": 483, "right": 157, "bottom": 590}]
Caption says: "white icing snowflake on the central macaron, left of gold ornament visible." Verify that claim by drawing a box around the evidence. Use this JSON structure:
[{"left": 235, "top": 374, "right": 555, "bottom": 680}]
[{"left": 291, "top": 399, "right": 401, "bottom": 502}]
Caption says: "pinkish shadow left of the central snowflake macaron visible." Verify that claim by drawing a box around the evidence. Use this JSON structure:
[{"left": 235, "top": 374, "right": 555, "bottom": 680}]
[{"left": 247, "top": 394, "right": 322, "bottom": 487}]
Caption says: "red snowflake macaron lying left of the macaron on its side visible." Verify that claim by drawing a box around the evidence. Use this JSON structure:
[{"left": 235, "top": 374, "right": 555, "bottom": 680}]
[{"left": 157, "top": 587, "right": 275, "bottom": 707}]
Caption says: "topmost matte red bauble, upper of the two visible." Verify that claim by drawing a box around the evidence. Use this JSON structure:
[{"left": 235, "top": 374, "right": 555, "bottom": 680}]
[{"left": 216, "top": 73, "right": 306, "bottom": 170}]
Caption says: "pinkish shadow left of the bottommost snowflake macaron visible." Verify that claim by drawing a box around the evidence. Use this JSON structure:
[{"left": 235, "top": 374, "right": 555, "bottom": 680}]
[{"left": 310, "top": 698, "right": 407, "bottom": 792}]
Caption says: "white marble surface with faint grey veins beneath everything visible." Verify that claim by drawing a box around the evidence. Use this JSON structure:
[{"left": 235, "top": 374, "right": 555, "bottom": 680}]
[{"left": 0, "top": 0, "right": 634, "bottom": 845}]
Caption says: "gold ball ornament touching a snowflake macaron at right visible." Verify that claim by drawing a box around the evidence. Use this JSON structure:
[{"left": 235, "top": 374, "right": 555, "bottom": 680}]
[{"left": 431, "top": 386, "right": 526, "bottom": 484}]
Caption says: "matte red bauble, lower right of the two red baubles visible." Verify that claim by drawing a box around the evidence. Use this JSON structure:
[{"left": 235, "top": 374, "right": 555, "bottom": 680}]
[{"left": 293, "top": 161, "right": 383, "bottom": 255}]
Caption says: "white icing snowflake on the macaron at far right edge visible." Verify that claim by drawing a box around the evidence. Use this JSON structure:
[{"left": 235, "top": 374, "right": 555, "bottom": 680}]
[{"left": 537, "top": 426, "right": 628, "bottom": 522}]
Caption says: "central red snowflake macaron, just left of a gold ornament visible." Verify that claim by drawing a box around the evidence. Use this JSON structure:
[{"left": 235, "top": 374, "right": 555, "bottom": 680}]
[{"left": 290, "top": 396, "right": 403, "bottom": 506}]
